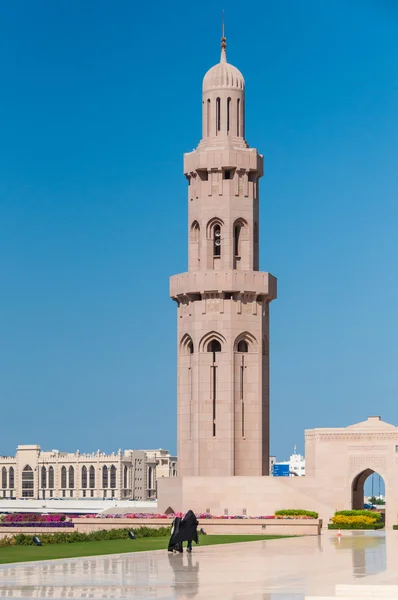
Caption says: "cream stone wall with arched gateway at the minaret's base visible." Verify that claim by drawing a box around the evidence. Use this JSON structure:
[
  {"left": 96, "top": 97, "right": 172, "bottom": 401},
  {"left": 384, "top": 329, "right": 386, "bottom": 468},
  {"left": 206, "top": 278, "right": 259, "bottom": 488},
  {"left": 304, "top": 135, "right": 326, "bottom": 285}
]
[{"left": 159, "top": 417, "right": 398, "bottom": 528}]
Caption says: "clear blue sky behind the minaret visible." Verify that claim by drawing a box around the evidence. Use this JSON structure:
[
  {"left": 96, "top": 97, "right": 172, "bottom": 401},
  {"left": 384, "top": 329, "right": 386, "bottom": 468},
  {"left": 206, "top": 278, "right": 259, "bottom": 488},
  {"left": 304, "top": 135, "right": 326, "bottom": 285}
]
[{"left": 0, "top": 0, "right": 398, "bottom": 459}]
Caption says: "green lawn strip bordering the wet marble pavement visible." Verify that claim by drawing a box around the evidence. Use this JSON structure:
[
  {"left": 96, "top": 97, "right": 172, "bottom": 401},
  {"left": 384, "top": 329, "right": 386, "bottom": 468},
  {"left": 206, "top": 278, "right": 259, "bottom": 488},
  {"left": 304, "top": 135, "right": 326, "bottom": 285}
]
[{"left": 0, "top": 535, "right": 288, "bottom": 564}]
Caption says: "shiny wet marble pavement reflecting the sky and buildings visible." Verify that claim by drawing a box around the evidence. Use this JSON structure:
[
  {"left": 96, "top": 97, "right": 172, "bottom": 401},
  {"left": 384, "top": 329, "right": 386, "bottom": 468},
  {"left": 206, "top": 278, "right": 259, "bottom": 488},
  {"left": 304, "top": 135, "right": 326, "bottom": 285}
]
[{"left": 0, "top": 531, "right": 398, "bottom": 600}]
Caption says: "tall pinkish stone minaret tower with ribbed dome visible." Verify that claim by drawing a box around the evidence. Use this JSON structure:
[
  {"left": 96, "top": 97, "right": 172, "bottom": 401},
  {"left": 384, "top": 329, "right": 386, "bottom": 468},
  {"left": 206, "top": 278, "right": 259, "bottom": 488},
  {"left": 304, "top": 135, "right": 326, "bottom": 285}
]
[{"left": 170, "top": 32, "right": 276, "bottom": 477}]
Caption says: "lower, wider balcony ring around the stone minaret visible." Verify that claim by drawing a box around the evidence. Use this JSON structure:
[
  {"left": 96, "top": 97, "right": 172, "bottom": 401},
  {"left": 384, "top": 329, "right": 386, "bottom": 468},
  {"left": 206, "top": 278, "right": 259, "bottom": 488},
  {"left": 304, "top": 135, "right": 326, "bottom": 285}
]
[{"left": 170, "top": 270, "right": 276, "bottom": 301}]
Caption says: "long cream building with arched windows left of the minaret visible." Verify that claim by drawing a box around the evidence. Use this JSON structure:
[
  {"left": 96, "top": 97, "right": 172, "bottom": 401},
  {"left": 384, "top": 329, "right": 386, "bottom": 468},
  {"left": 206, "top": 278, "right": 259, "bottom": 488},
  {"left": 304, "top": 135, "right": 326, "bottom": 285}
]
[{"left": 0, "top": 445, "right": 176, "bottom": 500}]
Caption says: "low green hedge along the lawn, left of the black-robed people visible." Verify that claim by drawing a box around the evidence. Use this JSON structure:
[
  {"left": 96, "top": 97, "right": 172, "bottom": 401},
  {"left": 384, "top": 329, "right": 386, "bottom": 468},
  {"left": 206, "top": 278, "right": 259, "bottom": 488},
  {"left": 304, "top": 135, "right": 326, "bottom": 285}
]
[{"left": 0, "top": 527, "right": 171, "bottom": 547}]
